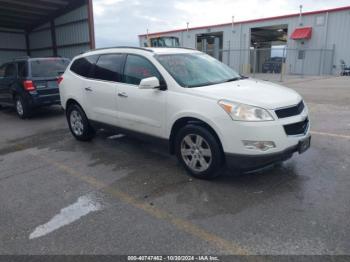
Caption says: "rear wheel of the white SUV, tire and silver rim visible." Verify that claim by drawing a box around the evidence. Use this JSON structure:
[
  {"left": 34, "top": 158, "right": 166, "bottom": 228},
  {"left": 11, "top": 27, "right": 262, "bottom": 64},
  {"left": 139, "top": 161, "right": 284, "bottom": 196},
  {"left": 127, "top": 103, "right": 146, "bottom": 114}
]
[{"left": 67, "top": 104, "right": 95, "bottom": 141}]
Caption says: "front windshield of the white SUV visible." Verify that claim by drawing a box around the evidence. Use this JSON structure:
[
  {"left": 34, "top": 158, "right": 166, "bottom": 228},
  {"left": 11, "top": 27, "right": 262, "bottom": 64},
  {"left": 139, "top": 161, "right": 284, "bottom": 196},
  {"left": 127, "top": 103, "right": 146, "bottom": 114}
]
[{"left": 156, "top": 53, "right": 241, "bottom": 87}]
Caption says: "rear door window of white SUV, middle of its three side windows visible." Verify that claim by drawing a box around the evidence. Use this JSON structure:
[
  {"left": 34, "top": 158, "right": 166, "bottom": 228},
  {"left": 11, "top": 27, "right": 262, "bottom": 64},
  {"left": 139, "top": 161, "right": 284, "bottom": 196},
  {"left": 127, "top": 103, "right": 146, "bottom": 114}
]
[{"left": 94, "top": 54, "right": 125, "bottom": 82}]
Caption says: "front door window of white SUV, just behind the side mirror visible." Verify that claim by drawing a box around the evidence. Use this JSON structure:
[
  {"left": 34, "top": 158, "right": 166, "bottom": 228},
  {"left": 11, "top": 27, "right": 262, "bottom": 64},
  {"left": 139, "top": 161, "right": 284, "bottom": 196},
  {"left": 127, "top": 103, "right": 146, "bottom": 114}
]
[{"left": 124, "top": 55, "right": 162, "bottom": 85}]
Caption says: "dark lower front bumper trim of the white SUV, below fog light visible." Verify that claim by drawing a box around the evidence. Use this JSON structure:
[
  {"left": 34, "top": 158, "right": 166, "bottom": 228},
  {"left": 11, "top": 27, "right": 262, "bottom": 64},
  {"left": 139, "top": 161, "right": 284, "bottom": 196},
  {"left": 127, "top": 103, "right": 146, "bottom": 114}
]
[{"left": 225, "top": 135, "right": 311, "bottom": 171}]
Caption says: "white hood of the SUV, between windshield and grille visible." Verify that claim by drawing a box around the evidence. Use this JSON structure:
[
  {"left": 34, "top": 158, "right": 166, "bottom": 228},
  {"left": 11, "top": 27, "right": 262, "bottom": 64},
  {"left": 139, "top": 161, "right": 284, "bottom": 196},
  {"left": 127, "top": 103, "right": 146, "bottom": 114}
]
[{"left": 188, "top": 79, "right": 302, "bottom": 109}]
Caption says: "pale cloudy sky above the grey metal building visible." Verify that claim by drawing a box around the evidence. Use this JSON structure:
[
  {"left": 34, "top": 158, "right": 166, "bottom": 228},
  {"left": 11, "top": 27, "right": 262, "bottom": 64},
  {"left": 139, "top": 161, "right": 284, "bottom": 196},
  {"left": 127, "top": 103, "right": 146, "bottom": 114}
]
[{"left": 93, "top": 0, "right": 350, "bottom": 47}]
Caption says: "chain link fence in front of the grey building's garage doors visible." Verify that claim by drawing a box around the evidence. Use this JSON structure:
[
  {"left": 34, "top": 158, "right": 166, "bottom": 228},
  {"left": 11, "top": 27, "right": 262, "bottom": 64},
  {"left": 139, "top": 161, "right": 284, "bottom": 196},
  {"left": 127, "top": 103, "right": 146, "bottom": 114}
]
[{"left": 206, "top": 48, "right": 334, "bottom": 81}]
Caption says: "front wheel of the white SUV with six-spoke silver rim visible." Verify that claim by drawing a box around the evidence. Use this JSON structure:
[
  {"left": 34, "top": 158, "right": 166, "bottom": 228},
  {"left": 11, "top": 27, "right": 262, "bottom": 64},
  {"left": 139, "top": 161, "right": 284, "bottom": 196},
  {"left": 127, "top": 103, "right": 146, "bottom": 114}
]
[{"left": 175, "top": 125, "right": 224, "bottom": 179}]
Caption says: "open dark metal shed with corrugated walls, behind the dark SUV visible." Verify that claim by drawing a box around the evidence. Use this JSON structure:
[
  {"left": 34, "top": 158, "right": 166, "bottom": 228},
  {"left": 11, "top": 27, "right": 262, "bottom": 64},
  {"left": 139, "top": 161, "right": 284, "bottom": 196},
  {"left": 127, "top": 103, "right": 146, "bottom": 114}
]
[{"left": 0, "top": 0, "right": 95, "bottom": 62}]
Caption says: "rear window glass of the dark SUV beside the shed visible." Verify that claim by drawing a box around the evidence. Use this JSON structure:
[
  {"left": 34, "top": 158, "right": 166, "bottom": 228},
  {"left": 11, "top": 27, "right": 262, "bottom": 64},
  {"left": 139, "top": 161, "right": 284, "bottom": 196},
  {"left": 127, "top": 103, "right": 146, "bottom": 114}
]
[{"left": 30, "top": 58, "right": 69, "bottom": 77}]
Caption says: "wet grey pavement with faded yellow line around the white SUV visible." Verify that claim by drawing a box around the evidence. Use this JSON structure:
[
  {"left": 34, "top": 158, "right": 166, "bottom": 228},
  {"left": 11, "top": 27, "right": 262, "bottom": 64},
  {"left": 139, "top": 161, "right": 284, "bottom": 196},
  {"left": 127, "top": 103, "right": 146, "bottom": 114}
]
[{"left": 0, "top": 77, "right": 350, "bottom": 255}]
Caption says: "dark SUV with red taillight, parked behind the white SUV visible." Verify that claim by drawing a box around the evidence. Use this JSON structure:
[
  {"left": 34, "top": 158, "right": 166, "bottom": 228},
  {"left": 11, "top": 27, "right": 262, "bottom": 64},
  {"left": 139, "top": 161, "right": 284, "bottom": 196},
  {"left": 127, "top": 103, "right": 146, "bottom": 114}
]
[{"left": 0, "top": 57, "right": 70, "bottom": 118}]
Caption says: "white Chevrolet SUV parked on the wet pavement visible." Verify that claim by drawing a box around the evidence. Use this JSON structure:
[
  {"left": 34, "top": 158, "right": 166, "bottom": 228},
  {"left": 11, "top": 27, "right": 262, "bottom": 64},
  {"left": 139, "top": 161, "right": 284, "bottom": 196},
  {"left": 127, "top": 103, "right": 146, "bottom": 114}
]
[{"left": 59, "top": 47, "right": 311, "bottom": 178}]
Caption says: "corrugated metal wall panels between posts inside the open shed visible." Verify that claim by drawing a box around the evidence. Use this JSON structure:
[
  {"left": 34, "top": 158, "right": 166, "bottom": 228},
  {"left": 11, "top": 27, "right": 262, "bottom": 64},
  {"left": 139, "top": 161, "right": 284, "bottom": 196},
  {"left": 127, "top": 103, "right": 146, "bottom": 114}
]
[{"left": 0, "top": 1, "right": 94, "bottom": 64}]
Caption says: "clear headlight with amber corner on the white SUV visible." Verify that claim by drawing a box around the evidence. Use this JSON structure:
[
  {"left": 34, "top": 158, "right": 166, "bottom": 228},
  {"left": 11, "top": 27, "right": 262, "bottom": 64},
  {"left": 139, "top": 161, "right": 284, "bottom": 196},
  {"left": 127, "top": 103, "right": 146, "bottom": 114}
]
[{"left": 218, "top": 100, "right": 273, "bottom": 121}]
